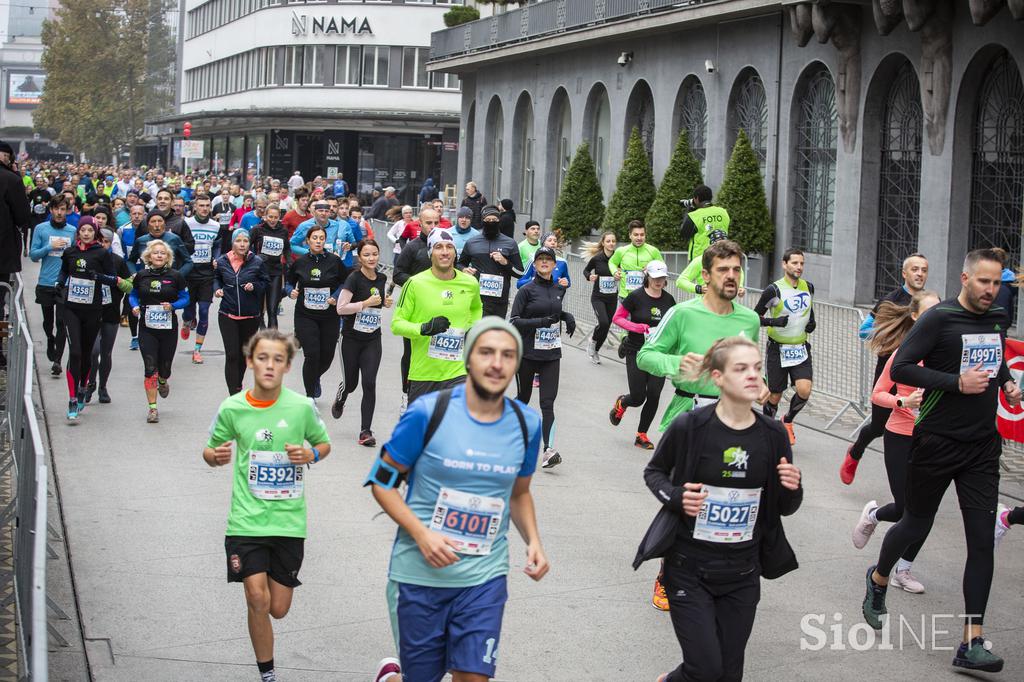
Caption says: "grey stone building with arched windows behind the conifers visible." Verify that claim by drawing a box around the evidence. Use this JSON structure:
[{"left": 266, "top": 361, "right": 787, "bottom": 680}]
[{"left": 430, "top": 0, "right": 1024, "bottom": 303}]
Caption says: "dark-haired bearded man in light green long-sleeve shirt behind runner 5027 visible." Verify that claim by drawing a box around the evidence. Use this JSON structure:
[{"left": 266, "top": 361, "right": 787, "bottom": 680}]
[{"left": 637, "top": 241, "right": 761, "bottom": 431}]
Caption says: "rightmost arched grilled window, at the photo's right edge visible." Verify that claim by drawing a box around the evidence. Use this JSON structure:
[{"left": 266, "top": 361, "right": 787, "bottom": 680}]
[{"left": 968, "top": 52, "right": 1024, "bottom": 274}]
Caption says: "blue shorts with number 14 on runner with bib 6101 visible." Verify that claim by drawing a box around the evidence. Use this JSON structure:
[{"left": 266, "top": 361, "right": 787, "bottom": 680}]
[{"left": 397, "top": 576, "right": 508, "bottom": 682}]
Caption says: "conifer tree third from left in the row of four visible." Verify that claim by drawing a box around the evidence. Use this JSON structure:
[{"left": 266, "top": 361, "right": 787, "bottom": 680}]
[{"left": 645, "top": 130, "right": 703, "bottom": 251}]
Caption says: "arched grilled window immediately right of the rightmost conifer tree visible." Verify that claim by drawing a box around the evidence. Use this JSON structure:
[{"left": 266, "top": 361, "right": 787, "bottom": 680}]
[{"left": 793, "top": 65, "right": 839, "bottom": 255}]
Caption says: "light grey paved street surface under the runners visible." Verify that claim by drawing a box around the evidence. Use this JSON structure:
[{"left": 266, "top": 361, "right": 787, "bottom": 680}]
[{"left": 26, "top": 259, "right": 1024, "bottom": 682}]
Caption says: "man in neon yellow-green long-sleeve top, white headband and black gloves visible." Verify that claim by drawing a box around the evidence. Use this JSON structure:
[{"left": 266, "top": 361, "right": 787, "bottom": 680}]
[{"left": 391, "top": 229, "right": 483, "bottom": 404}]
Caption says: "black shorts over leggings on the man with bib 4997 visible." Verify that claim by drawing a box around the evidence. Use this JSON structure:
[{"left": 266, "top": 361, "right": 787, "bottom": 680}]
[{"left": 905, "top": 431, "right": 1002, "bottom": 516}]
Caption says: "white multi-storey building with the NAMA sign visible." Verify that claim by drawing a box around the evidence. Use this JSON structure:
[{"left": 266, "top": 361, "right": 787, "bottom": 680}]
[{"left": 174, "top": 0, "right": 460, "bottom": 202}]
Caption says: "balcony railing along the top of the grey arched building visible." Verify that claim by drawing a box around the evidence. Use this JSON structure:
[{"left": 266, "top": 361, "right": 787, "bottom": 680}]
[{"left": 430, "top": 0, "right": 722, "bottom": 61}]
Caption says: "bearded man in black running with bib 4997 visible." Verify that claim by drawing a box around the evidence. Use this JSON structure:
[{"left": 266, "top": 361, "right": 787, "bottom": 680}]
[{"left": 863, "top": 249, "right": 1021, "bottom": 673}]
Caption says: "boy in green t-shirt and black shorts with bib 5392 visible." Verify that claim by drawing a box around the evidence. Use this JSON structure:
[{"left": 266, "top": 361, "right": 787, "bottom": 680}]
[{"left": 203, "top": 329, "right": 331, "bottom": 682}]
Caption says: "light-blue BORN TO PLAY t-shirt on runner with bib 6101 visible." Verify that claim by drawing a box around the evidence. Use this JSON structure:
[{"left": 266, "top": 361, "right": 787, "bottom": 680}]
[{"left": 384, "top": 386, "right": 541, "bottom": 588}]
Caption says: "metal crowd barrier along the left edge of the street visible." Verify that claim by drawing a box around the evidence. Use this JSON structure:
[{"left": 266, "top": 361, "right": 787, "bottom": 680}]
[{"left": 0, "top": 275, "right": 48, "bottom": 682}]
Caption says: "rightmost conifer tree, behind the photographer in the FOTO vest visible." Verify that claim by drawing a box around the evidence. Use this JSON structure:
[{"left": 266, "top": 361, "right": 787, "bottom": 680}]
[{"left": 715, "top": 130, "right": 775, "bottom": 259}]
